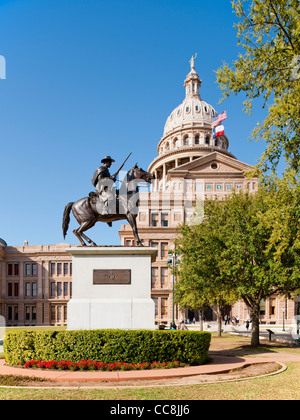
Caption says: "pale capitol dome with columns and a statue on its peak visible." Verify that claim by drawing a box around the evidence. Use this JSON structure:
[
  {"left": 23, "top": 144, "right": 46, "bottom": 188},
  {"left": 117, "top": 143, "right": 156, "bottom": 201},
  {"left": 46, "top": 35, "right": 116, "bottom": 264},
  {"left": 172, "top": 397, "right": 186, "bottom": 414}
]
[{"left": 148, "top": 57, "right": 235, "bottom": 184}]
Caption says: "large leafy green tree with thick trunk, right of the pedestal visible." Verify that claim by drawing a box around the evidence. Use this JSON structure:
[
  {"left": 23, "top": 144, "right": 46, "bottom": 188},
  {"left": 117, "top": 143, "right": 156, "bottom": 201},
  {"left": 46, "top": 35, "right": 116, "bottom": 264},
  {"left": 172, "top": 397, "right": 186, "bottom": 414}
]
[{"left": 175, "top": 178, "right": 300, "bottom": 346}]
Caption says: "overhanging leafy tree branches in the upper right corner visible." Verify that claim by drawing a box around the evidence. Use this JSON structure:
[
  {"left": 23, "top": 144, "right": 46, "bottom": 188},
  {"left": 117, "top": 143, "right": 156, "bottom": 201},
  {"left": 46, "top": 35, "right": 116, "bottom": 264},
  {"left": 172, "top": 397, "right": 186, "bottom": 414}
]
[{"left": 217, "top": 0, "right": 300, "bottom": 173}]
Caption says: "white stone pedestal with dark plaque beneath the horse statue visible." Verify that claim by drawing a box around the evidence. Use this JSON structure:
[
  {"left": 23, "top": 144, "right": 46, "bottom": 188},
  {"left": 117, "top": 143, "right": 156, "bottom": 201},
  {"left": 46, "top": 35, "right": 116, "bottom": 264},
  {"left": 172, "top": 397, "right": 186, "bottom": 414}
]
[{"left": 67, "top": 246, "right": 156, "bottom": 330}]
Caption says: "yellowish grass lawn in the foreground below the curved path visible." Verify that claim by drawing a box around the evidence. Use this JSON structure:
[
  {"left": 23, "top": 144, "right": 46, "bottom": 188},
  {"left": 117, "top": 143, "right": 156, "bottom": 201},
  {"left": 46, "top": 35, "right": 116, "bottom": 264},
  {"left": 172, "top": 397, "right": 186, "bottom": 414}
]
[{"left": 0, "top": 362, "right": 300, "bottom": 400}]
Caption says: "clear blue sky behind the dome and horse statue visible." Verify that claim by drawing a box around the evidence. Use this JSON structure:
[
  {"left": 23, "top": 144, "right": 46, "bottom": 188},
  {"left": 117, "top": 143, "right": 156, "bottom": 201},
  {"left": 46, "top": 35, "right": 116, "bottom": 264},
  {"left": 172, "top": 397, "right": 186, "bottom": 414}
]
[{"left": 0, "top": 0, "right": 264, "bottom": 245}]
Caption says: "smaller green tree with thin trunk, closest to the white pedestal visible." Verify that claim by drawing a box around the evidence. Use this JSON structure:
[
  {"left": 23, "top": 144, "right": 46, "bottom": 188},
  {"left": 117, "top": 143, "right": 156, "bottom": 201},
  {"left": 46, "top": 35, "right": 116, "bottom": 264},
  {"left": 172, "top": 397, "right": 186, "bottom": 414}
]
[{"left": 175, "top": 208, "right": 237, "bottom": 336}]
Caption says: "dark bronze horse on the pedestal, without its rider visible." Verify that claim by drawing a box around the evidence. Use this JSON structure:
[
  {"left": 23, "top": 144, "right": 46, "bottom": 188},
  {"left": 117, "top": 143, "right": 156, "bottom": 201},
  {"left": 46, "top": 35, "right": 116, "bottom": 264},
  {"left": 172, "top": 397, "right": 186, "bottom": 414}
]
[{"left": 62, "top": 164, "right": 154, "bottom": 246}]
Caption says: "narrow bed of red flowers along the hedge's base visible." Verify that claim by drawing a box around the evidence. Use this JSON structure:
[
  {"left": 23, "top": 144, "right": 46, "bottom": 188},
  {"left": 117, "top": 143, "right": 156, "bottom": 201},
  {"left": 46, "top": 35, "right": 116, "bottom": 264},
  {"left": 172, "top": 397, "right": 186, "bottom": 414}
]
[{"left": 24, "top": 360, "right": 187, "bottom": 372}]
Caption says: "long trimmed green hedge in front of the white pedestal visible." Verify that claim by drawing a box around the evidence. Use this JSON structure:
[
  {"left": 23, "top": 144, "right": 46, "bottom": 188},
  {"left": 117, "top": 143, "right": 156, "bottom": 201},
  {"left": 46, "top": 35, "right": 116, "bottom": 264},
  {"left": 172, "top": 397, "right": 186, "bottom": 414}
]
[{"left": 3, "top": 330, "right": 211, "bottom": 365}]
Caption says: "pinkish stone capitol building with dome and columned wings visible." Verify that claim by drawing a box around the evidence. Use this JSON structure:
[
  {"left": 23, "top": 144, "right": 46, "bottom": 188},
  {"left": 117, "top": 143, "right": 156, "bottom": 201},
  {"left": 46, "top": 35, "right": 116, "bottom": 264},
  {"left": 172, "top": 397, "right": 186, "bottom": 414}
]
[{"left": 0, "top": 59, "right": 300, "bottom": 326}]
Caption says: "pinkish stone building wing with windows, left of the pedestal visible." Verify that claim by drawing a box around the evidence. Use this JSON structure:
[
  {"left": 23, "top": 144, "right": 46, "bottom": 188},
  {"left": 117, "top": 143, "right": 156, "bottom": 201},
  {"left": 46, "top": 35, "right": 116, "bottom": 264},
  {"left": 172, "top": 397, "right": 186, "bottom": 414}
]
[{"left": 0, "top": 242, "right": 72, "bottom": 326}]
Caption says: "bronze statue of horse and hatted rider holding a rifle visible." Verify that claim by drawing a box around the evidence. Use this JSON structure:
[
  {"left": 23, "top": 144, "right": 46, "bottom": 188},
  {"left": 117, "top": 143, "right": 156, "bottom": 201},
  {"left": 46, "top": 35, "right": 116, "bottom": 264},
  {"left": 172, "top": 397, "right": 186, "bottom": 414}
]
[{"left": 62, "top": 153, "right": 154, "bottom": 246}]
